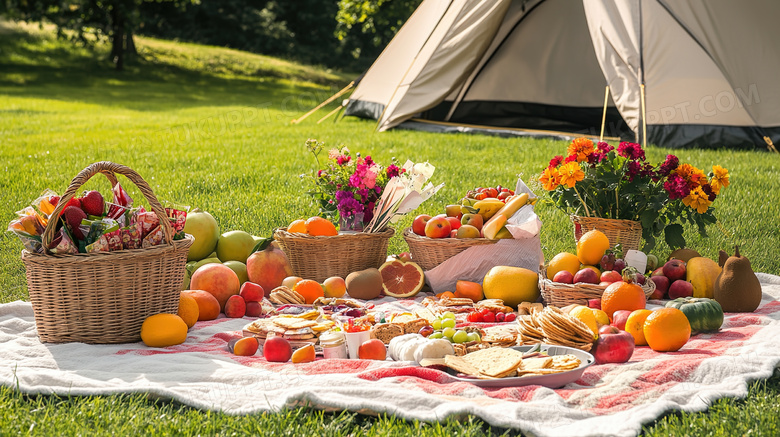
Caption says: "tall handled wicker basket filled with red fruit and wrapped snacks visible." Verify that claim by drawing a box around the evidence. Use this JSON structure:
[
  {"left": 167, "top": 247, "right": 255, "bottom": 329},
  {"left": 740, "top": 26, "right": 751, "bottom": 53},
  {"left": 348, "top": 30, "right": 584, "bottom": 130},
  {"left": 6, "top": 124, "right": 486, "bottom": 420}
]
[{"left": 12, "top": 162, "right": 194, "bottom": 344}]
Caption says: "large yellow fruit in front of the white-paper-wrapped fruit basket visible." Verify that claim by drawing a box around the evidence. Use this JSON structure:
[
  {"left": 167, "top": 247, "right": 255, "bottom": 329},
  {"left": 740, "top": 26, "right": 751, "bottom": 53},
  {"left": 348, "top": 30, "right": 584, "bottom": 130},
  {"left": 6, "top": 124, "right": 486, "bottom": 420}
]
[{"left": 482, "top": 266, "right": 539, "bottom": 308}]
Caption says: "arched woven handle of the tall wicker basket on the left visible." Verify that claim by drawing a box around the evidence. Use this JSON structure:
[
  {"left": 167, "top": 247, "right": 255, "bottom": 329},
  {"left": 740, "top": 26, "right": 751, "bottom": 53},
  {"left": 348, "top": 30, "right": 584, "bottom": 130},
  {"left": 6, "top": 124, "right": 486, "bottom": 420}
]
[{"left": 42, "top": 161, "right": 173, "bottom": 252}]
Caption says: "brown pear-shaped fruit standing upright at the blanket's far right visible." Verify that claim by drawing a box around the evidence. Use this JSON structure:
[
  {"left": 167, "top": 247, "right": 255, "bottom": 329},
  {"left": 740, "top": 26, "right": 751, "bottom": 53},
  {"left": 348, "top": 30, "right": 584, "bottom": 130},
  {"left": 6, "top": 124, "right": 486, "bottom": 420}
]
[{"left": 713, "top": 246, "right": 761, "bottom": 313}]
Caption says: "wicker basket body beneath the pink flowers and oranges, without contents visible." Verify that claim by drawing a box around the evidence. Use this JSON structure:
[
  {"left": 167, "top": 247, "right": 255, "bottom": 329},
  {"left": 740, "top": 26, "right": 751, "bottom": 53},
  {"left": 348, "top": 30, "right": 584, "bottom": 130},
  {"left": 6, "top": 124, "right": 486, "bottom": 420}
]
[{"left": 274, "top": 228, "right": 395, "bottom": 282}]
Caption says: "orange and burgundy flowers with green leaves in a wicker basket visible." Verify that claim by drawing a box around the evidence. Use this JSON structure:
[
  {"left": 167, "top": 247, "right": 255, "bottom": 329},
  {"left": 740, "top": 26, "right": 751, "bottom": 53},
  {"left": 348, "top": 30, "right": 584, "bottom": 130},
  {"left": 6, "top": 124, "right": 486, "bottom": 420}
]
[{"left": 539, "top": 138, "right": 729, "bottom": 250}]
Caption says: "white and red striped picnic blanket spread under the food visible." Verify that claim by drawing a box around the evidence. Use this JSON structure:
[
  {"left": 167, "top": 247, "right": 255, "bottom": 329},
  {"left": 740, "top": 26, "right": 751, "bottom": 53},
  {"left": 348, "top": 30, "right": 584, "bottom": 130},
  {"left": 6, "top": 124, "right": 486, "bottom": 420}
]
[{"left": 0, "top": 274, "right": 780, "bottom": 436}]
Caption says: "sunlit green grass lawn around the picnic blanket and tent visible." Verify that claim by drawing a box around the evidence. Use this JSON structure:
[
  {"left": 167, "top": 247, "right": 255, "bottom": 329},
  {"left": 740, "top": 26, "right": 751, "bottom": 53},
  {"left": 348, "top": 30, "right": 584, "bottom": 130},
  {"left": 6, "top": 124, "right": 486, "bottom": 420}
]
[{"left": 0, "top": 22, "right": 780, "bottom": 436}]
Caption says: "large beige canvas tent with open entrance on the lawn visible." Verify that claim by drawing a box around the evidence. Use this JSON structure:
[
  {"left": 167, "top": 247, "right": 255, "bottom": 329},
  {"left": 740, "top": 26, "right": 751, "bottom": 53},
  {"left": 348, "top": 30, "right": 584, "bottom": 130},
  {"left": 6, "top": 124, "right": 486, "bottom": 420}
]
[{"left": 345, "top": 0, "right": 780, "bottom": 149}]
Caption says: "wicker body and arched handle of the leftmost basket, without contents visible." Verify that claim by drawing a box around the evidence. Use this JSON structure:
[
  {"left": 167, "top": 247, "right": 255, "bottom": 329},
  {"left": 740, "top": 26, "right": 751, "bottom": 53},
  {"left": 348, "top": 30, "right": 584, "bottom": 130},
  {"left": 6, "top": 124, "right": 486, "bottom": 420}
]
[{"left": 22, "top": 162, "right": 194, "bottom": 344}]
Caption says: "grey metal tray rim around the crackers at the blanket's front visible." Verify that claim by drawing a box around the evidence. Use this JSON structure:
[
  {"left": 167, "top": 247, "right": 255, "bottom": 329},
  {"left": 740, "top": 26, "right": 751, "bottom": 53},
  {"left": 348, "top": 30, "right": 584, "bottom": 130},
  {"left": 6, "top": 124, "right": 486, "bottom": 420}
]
[{"left": 438, "top": 344, "right": 596, "bottom": 388}]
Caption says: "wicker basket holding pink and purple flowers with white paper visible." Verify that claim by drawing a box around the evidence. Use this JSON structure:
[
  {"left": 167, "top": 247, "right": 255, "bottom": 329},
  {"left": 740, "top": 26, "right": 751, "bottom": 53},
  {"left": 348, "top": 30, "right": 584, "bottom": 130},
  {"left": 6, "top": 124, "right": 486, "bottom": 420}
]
[{"left": 274, "top": 139, "right": 440, "bottom": 281}]
